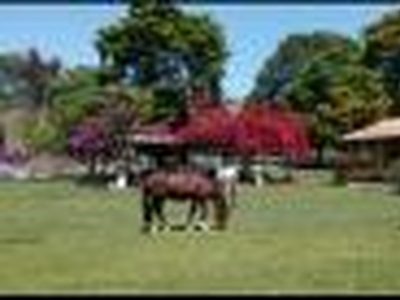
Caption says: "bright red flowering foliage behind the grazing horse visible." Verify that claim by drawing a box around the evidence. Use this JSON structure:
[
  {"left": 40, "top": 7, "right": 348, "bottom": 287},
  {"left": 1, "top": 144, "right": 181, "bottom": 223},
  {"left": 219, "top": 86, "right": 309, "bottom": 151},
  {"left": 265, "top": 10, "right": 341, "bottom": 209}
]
[{"left": 178, "top": 104, "right": 310, "bottom": 159}]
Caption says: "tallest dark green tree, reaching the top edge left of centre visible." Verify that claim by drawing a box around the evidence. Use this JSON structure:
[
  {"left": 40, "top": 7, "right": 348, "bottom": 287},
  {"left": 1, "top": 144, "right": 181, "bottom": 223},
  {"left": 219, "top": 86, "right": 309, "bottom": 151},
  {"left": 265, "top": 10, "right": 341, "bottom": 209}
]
[{"left": 96, "top": 0, "right": 227, "bottom": 122}]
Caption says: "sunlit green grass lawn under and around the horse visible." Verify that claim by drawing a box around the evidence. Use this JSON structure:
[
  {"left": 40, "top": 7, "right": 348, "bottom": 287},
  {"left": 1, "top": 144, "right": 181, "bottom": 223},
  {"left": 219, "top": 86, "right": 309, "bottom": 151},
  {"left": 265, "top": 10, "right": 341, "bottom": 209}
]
[{"left": 0, "top": 175, "right": 400, "bottom": 293}]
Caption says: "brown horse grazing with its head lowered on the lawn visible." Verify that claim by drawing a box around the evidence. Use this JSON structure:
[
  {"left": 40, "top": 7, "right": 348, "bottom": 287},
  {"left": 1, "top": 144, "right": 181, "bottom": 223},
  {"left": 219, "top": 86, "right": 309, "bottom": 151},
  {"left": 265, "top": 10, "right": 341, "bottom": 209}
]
[{"left": 140, "top": 168, "right": 229, "bottom": 232}]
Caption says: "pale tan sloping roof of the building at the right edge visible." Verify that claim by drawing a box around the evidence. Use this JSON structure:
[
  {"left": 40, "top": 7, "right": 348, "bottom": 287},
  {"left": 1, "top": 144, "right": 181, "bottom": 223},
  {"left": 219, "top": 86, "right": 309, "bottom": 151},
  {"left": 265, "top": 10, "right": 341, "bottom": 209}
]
[{"left": 343, "top": 118, "right": 400, "bottom": 142}]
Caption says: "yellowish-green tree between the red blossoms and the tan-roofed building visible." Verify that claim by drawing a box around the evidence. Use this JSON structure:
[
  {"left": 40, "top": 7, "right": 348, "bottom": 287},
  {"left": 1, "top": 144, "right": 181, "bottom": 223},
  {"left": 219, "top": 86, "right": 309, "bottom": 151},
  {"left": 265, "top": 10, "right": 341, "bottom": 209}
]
[{"left": 283, "top": 50, "right": 392, "bottom": 158}]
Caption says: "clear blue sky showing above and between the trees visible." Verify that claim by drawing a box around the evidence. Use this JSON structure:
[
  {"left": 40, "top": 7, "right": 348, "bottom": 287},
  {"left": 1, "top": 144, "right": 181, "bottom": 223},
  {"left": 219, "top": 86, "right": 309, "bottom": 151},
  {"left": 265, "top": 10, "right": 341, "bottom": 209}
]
[{"left": 0, "top": 4, "right": 400, "bottom": 98}]
